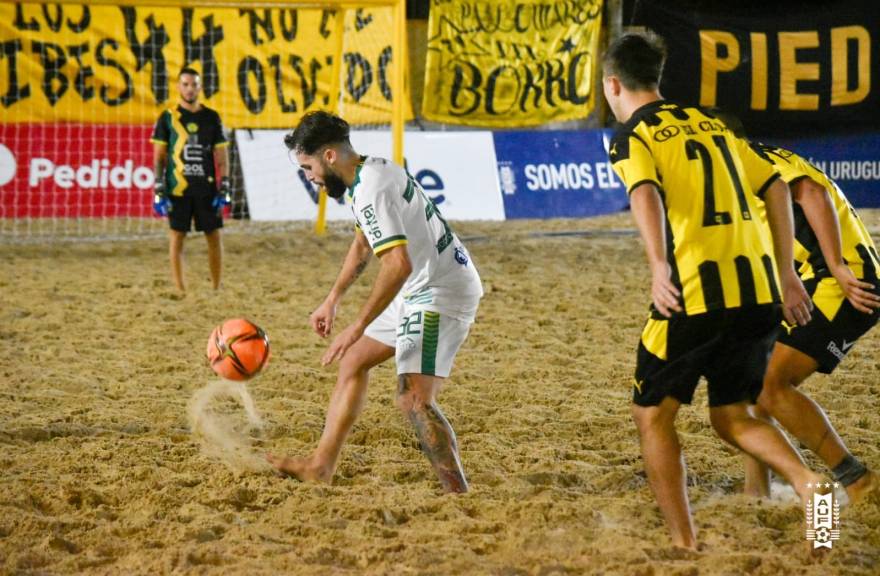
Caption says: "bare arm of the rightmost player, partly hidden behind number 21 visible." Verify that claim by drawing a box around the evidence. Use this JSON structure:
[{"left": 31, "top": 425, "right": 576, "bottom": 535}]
[{"left": 791, "top": 178, "right": 880, "bottom": 314}]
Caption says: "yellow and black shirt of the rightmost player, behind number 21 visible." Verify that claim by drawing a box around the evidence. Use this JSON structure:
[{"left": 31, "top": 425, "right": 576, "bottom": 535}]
[{"left": 752, "top": 143, "right": 880, "bottom": 280}]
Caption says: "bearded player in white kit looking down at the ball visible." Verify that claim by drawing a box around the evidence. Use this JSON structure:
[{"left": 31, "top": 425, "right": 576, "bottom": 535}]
[{"left": 268, "top": 111, "right": 483, "bottom": 492}]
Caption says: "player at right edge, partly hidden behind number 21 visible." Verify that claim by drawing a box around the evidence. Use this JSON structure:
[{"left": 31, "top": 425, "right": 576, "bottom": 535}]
[{"left": 731, "top": 141, "right": 880, "bottom": 501}]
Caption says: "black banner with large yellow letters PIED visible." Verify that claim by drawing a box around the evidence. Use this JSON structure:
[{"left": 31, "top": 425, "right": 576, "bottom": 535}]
[{"left": 632, "top": 0, "right": 880, "bottom": 137}]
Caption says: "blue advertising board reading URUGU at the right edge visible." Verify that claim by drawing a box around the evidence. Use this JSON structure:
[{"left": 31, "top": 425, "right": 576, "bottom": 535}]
[{"left": 765, "top": 134, "right": 880, "bottom": 208}]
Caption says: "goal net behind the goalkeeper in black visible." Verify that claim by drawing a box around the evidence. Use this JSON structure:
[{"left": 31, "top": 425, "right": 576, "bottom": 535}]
[{"left": 0, "top": 0, "right": 411, "bottom": 241}]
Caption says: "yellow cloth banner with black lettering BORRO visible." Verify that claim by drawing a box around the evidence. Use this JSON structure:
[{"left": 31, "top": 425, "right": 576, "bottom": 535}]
[{"left": 422, "top": 0, "right": 602, "bottom": 128}]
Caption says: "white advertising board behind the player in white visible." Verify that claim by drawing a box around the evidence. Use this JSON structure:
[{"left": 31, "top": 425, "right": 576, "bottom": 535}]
[{"left": 236, "top": 130, "right": 504, "bottom": 221}]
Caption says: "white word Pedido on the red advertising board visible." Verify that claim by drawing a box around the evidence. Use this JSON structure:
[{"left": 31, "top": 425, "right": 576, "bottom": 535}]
[{"left": 28, "top": 158, "right": 155, "bottom": 190}]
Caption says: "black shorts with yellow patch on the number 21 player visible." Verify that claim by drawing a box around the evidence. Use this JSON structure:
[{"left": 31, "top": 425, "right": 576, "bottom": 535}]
[{"left": 633, "top": 304, "right": 780, "bottom": 406}]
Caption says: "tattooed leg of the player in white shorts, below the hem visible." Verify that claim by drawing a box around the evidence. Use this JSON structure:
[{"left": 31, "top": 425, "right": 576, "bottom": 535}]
[{"left": 397, "top": 374, "right": 468, "bottom": 492}]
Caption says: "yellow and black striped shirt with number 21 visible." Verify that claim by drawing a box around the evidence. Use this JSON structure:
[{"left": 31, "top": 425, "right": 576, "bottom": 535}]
[{"left": 609, "top": 100, "right": 780, "bottom": 315}]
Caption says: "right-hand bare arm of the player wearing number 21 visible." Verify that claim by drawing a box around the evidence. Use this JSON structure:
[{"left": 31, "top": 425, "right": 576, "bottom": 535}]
[{"left": 764, "top": 178, "right": 813, "bottom": 326}]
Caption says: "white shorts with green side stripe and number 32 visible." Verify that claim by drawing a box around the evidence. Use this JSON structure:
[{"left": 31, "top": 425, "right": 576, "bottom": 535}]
[{"left": 364, "top": 294, "right": 473, "bottom": 378}]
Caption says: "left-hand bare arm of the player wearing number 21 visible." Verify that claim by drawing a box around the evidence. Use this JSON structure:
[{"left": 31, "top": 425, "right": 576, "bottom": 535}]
[{"left": 630, "top": 183, "right": 682, "bottom": 317}]
